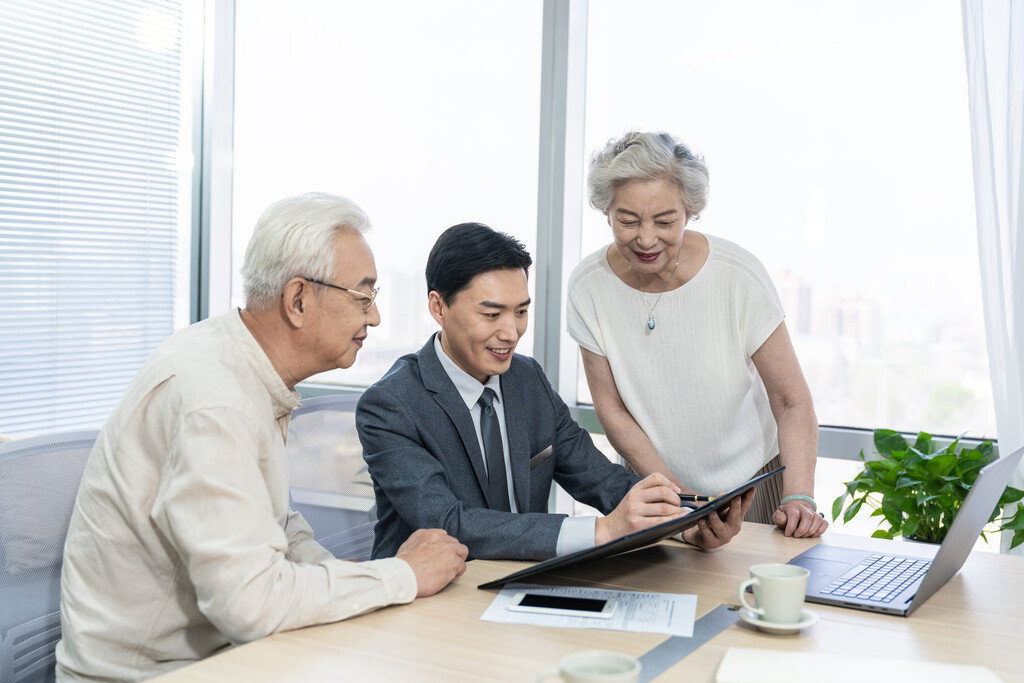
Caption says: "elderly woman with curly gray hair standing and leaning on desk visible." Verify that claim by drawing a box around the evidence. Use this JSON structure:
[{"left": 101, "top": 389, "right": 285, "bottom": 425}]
[{"left": 567, "top": 132, "right": 828, "bottom": 537}]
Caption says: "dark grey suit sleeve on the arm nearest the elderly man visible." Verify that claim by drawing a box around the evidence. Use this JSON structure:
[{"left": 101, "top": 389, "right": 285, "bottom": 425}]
[{"left": 356, "top": 386, "right": 564, "bottom": 560}]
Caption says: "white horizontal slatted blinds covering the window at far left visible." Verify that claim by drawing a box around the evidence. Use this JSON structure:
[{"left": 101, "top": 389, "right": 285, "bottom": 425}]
[{"left": 0, "top": 0, "right": 187, "bottom": 435}]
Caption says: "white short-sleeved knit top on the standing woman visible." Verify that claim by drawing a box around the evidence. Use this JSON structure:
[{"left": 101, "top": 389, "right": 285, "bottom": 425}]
[{"left": 566, "top": 236, "right": 783, "bottom": 495}]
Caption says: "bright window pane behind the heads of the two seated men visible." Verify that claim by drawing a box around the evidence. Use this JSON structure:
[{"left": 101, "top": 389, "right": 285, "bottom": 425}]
[{"left": 232, "top": 0, "right": 542, "bottom": 386}]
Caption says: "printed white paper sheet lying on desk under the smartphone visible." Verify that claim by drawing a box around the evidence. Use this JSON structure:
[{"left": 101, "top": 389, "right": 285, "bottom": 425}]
[{"left": 480, "top": 584, "right": 697, "bottom": 638}]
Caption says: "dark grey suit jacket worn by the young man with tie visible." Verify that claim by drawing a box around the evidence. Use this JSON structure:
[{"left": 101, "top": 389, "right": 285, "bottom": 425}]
[{"left": 355, "top": 338, "right": 639, "bottom": 560}]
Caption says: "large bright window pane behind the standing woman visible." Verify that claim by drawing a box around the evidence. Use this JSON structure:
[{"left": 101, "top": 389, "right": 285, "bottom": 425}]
[{"left": 579, "top": 0, "right": 995, "bottom": 436}]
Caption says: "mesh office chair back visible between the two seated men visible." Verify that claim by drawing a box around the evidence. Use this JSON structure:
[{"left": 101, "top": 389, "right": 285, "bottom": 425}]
[{"left": 287, "top": 394, "right": 377, "bottom": 560}]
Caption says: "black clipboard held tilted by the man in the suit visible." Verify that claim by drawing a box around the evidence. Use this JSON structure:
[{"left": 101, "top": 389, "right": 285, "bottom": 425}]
[{"left": 477, "top": 466, "right": 785, "bottom": 590}]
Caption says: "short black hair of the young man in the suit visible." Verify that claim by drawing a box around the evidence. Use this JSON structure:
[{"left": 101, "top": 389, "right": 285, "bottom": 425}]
[{"left": 427, "top": 223, "right": 534, "bottom": 306}]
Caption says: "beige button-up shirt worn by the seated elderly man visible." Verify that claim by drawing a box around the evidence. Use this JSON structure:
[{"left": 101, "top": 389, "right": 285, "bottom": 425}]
[{"left": 56, "top": 310, "right": 417, "bottom": 680}]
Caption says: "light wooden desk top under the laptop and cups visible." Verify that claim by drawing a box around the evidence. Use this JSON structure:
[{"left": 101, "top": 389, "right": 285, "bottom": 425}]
[{"left": 159, "top": 524, "right": 1024, "bottom": 683}]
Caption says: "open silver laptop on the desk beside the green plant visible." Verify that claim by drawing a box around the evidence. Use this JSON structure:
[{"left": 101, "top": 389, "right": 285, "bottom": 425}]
[{"left": 790, "top": 447, "right": 1024, "bottom": 616}]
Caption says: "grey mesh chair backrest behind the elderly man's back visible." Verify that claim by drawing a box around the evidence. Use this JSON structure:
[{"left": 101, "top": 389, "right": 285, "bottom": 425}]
[{"left": 0, "top": 430, "right": 99, "bottom": 683}]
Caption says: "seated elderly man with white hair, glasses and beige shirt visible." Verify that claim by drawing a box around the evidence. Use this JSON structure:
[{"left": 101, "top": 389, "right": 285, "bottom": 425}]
[{"left": 57, "top": 195, "right": 467, "bottom": 680}]
